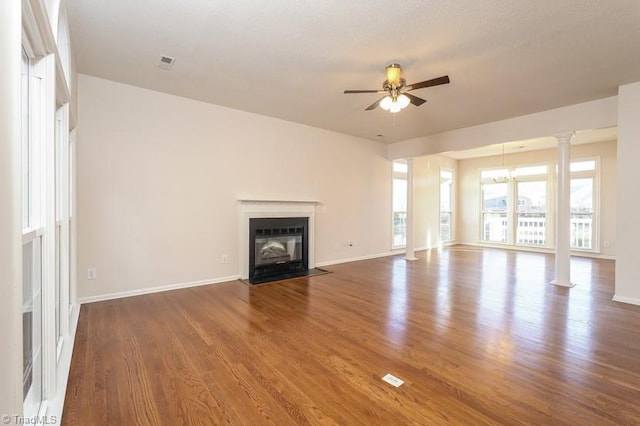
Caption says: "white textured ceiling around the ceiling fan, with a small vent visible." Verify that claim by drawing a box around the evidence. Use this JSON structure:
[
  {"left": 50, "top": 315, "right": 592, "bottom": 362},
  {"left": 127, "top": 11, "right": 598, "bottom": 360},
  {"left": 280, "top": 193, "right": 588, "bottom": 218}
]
[{"left": 67, "top": 0, "right": 640, "bottom": 143}]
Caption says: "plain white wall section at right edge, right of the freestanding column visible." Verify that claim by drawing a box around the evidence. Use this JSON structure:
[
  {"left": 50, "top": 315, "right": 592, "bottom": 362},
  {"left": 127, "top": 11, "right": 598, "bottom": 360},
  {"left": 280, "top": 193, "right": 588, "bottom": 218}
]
[{"left": 614, "top": 83, "right": 640, "bottom": 305}]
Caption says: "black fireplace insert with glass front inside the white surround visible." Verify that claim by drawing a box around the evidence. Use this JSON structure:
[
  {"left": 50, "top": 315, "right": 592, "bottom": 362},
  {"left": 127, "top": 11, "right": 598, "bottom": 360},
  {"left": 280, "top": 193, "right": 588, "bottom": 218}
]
[{"left": 248, "top": 217, "right": 309, "bottom": 284}]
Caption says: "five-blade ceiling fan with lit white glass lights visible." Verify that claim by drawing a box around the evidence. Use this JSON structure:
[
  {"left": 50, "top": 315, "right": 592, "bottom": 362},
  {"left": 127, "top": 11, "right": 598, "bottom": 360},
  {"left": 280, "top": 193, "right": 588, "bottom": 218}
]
[{"left": 344, "top": 64, "right": 449, "bottom": 113}]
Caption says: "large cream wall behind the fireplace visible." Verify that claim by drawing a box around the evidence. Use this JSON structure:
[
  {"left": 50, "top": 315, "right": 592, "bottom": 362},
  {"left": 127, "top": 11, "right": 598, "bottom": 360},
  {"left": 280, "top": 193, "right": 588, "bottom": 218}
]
[{"left": 77, "top": 75, "right": 391, "bottom": 300}]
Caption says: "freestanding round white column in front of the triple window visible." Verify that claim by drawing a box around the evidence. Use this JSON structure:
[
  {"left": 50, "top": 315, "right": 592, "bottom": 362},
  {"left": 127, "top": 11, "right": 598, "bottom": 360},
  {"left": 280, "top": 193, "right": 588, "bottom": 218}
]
[{"left": 551, "top": 132, "right": 575, "bottom": 287}]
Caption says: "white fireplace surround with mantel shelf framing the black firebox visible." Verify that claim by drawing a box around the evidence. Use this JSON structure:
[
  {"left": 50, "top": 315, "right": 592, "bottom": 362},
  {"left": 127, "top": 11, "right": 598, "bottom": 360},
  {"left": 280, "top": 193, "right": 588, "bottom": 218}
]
[{"left": 238, "top": 200, "right": 320, "bottom": 280}]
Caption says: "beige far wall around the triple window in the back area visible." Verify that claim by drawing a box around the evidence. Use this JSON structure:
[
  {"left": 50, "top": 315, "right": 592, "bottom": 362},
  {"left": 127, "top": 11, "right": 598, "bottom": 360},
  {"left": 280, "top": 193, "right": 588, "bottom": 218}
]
[{"left": 457, "top": 141, "right": 617, "bottom": 257}]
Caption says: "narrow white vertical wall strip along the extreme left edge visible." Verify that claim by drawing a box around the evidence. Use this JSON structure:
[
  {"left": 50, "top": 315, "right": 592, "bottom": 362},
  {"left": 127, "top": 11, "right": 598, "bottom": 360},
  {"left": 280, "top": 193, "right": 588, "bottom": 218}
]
[{"left": 0, "top": 0, "right": 22, "bottom": 414}]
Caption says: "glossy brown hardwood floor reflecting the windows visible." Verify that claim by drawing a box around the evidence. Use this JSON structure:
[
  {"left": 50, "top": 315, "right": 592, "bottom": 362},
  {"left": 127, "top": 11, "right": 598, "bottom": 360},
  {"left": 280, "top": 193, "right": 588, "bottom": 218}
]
[{"left": 62, "top": 246, "right": 640, "bottom": 425}]
